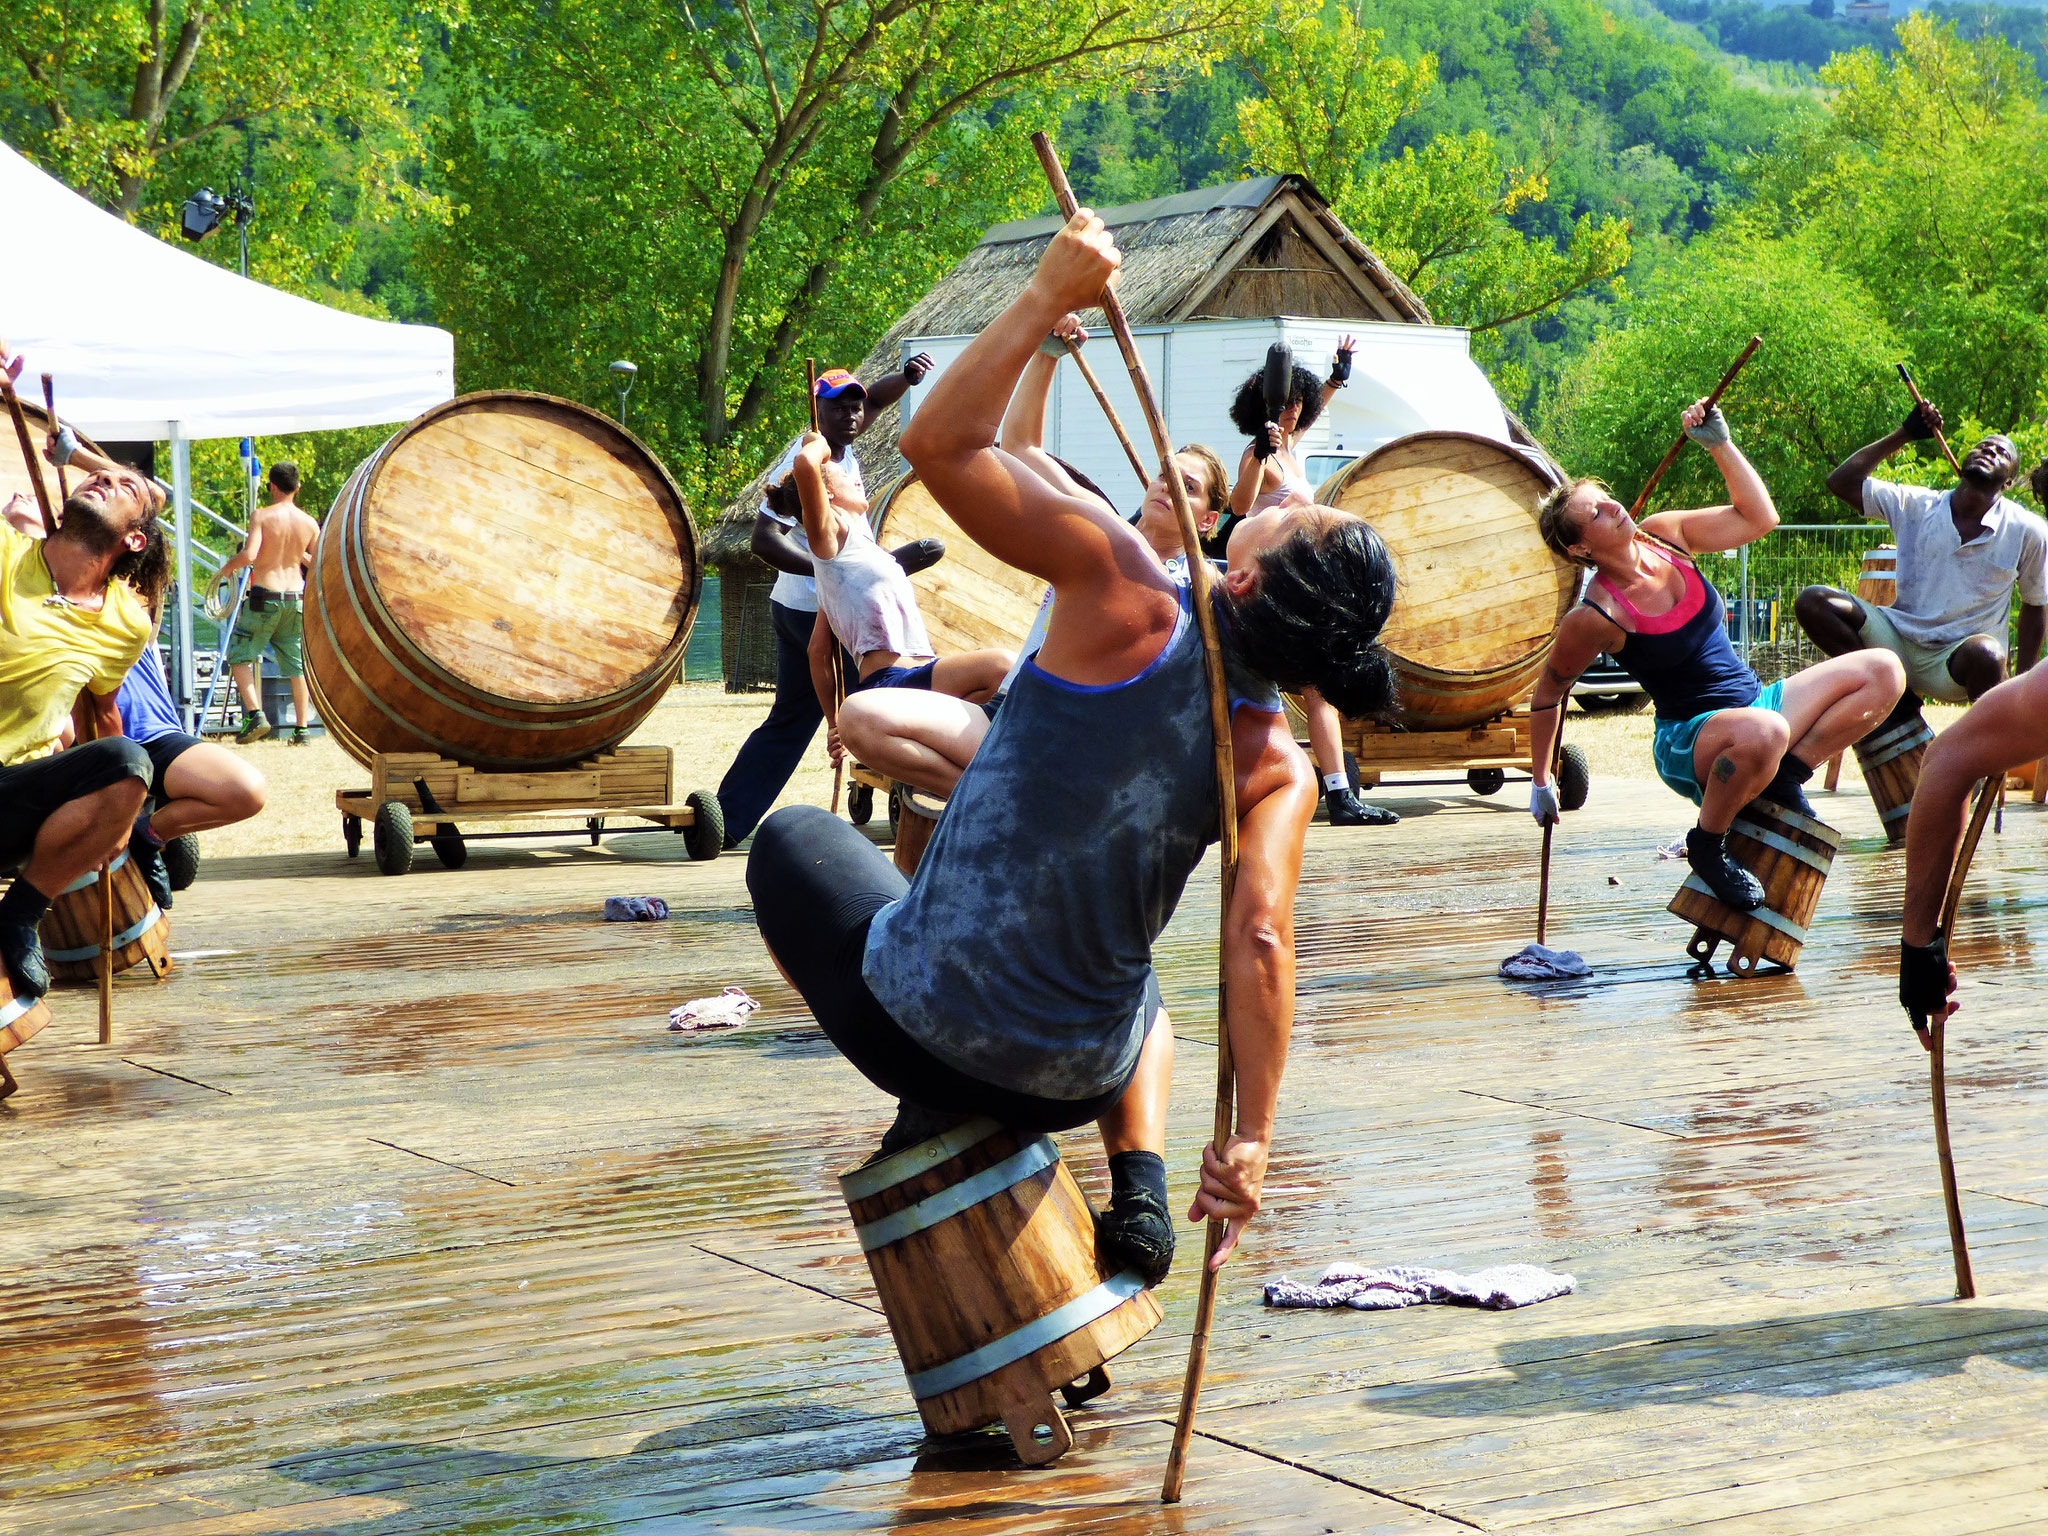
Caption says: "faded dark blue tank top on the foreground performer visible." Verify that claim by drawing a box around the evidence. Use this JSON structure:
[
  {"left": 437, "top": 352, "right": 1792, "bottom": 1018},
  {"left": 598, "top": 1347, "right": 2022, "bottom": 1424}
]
[{"left": 862, "top": 586, "right": 1280, "bottom": 1100}]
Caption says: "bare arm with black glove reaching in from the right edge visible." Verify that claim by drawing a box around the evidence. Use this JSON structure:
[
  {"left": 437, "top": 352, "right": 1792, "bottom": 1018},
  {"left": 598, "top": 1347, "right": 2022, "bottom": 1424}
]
[{"left": 1898, "top": 668, "right": 2048, "bottom": 1044}]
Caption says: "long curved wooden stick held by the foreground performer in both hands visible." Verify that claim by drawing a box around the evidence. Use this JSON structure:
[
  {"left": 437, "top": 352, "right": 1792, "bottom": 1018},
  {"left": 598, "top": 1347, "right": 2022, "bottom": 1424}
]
[{"left": 1030, "top": 133, "right": 1237, "bottom": 1503}]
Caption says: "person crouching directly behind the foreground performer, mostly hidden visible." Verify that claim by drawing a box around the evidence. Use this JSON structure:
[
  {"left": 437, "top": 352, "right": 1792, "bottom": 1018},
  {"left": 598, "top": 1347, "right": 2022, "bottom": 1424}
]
[{"left": 840, "top": 313, "right": 1231, "bottom": 799}]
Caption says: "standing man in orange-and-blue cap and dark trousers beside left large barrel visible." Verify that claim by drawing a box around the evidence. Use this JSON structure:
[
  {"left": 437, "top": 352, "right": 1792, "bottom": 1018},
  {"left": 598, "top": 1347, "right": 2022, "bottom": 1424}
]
[{"left": 719, "top": 352, "right": 942, "bottom": 848}]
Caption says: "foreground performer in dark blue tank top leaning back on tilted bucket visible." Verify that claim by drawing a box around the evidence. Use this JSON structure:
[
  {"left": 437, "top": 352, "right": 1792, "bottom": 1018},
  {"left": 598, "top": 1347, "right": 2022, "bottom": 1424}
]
[{"left": 748, "top": 209, "right": 1395, "bottom": 1282}]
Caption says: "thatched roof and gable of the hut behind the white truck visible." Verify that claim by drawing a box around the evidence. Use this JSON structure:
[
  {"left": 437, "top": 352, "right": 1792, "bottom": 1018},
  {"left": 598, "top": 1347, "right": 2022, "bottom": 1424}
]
[{"left": 705, "top": 176, "right": 1432, "bottom": 565}]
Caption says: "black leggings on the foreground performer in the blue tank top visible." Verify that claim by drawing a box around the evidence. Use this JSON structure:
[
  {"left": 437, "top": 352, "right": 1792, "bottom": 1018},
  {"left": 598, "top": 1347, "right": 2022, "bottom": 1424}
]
[{"left": 748, "top": 805, "right": 1137, "bottom": 1130}]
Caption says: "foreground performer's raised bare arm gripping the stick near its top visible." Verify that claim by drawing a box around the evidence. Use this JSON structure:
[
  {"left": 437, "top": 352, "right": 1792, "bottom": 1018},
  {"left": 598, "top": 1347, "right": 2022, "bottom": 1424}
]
[{"left": 899, "top": 209, "right": 1180, "bottom": 684}]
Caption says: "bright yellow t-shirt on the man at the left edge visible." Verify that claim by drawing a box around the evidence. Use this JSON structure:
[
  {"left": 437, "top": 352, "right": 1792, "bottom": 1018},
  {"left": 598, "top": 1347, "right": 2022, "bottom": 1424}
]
[{"left": 0, "top": 522, "right": 156, "bottom": 764}]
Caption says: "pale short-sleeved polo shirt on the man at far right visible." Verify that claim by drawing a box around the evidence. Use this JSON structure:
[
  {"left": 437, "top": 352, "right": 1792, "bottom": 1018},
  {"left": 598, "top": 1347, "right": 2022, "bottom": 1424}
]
[{"left": 1864, "top": 479, "right": 2048, "bottom": 651}]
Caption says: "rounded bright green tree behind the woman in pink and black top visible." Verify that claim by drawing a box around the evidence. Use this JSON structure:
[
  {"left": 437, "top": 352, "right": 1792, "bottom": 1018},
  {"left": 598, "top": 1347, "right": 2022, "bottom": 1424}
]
[{"left": 1542, "top": 233, "right": 1911, "bottom": 522}]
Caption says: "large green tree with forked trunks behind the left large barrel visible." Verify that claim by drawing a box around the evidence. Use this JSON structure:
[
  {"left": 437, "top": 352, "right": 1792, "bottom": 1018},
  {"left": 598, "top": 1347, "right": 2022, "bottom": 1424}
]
[{"left": 428, "top": 0, "right": 1239, "bottom": 499}]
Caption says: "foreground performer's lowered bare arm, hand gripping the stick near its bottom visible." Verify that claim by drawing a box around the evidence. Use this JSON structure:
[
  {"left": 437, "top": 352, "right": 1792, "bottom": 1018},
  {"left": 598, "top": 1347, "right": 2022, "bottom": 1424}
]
[{"left": 1188, "top": 709, "right": 1317, "bottom": 1266}]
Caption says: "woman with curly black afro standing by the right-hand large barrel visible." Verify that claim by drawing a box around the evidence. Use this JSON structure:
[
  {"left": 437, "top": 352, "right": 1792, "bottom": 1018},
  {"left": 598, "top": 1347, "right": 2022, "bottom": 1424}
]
[{"left": 1206, "top": 336, "right": 1401, "bottom": 827}]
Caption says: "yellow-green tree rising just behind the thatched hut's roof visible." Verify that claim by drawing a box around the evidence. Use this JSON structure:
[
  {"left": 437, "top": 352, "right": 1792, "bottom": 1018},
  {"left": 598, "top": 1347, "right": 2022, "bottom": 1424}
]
[{"left": 1212, "top": 0, "right": 1630, "bottom": 352}]
